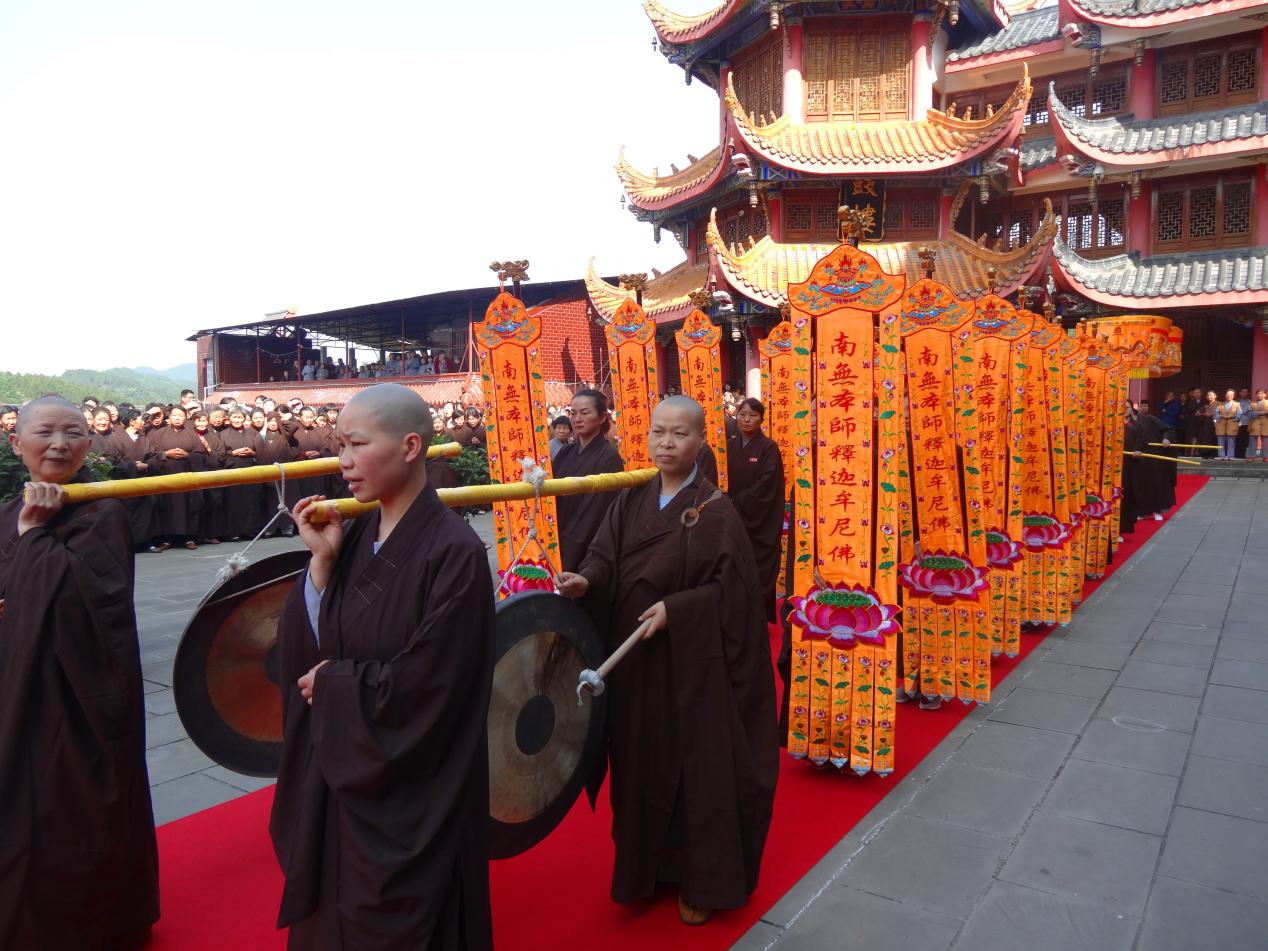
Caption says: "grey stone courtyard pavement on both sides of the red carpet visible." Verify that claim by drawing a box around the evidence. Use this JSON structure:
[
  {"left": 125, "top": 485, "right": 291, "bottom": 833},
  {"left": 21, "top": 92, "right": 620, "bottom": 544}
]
[{"left": 137, "top": 479, "right": 1268, "bottom": 951}]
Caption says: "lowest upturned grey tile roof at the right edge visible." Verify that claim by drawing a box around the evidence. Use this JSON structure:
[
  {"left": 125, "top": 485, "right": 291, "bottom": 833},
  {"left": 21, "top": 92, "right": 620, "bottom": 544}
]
[{"left": 1052, "top": 238, "right": 1268, "bottom": 298}]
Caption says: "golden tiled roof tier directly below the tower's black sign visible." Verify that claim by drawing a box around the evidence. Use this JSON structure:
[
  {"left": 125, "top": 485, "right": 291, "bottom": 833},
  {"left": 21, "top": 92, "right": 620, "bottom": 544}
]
[{"left": 706, "top": 199, "right": 1058, "bottom": 307}]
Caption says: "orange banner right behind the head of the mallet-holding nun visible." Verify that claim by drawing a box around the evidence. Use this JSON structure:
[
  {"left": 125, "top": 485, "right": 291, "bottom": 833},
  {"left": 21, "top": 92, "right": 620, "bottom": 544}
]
[{"left": 606, "top": 301, "right": 659, "bottom": 470}]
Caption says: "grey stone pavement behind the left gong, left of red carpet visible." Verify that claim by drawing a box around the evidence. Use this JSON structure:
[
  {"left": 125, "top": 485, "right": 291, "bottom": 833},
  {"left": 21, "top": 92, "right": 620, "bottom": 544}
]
[{"left": 136, "top": 515, "right": 497, "bottom": 824}]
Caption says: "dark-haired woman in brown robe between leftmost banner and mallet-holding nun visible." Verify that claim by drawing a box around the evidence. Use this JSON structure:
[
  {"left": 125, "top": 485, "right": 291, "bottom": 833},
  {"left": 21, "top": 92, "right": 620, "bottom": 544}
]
[{"left": 550, "top": 389, "right": 625, "bottom": 572}]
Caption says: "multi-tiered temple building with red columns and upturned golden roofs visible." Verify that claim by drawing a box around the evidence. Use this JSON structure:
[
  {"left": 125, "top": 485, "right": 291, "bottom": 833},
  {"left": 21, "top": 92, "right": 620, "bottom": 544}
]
[{"left": 586, "top": 0, "right": 1268, "bottom": 396}]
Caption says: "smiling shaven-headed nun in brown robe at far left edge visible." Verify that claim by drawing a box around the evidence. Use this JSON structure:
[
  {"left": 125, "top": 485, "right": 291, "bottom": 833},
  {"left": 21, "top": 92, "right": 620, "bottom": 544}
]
[{"left": 0, "top": 397, "right": 159, "bottom": 951}]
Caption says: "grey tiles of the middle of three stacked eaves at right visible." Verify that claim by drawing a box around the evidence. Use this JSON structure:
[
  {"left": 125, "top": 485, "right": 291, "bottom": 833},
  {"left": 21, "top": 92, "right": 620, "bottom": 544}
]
[{"left": 1047, "top": 84, "right": 1268, "bottom": 155}]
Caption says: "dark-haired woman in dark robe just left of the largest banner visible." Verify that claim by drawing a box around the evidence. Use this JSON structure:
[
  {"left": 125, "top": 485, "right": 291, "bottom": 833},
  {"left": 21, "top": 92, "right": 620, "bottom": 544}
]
[{"left": 727, "top": 397, "right": 784, "bottom": 621}]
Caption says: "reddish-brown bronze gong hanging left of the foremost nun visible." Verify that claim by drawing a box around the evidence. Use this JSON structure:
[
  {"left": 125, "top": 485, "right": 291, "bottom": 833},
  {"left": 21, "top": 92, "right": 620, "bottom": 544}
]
[{"left": 172, "top": 550, "right": 308, "bottom": 777}]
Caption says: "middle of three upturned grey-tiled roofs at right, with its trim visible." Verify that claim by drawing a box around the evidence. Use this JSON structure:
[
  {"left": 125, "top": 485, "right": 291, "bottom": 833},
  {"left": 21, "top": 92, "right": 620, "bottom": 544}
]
[{"left": 1047, "top": 85, "right": 1268, "bottom": 169}]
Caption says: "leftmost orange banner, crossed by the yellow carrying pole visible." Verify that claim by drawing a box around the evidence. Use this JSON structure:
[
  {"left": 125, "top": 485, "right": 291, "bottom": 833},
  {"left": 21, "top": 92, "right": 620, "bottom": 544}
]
[{"left": 474, "top": 292, "right": 559, "bottom": 588}]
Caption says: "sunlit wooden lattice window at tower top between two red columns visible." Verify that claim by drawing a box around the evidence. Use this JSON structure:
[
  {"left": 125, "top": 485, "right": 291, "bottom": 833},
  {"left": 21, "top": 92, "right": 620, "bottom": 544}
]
[{"left": 805, "top": 23, "right": 912, "bottom": 122}]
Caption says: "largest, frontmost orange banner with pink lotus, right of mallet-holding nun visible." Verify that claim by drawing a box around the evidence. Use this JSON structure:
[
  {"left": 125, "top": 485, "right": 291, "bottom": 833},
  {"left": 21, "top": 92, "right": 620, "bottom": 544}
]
[{"left": 789, "top": 245, "right": 905, "bottom": 775}]
